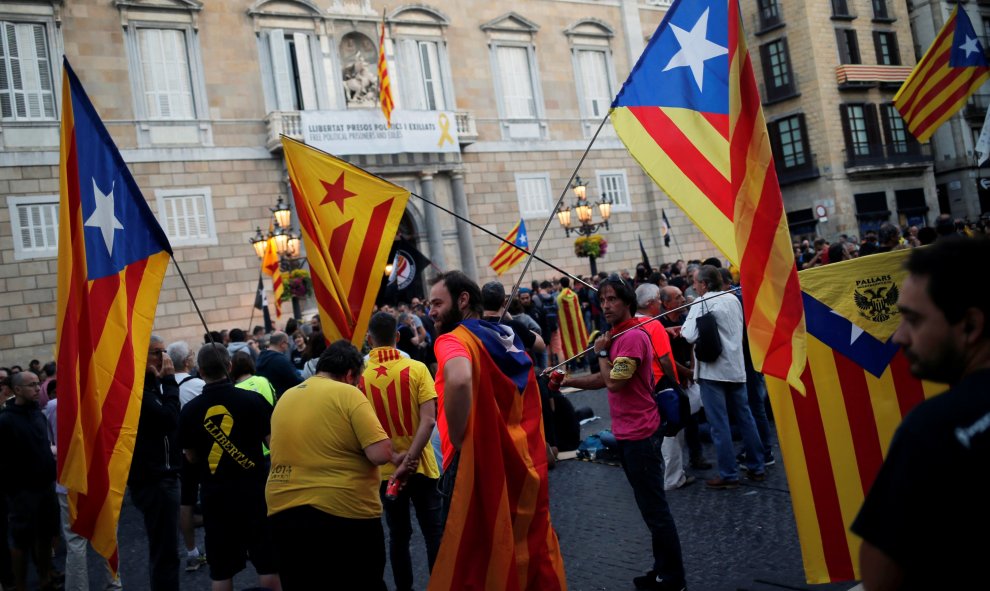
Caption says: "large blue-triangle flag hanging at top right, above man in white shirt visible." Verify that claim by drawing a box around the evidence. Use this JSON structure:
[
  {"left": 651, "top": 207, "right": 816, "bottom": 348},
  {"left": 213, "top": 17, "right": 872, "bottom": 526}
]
[{"left": 611, "top": 0, "right": 805, "bottom": 388}]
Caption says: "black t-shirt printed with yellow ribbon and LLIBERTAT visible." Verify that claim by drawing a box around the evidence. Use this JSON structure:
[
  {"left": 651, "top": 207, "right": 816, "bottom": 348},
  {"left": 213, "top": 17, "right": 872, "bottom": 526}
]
[{"left": 179, "top": 380, "right": 272, "bottom": 490}]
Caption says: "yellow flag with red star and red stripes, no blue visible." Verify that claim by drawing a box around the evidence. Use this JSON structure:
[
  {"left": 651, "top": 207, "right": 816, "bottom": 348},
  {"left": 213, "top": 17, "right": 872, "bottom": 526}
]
[{"left": 282, "top": 136, "right": 409, "bottom": 347}]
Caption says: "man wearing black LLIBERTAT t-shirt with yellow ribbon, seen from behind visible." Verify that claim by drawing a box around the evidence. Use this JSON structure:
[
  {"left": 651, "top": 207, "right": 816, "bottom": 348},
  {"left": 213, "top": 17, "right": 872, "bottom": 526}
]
[{"left": 179, "top": 344, "right": 281, "bottom": 591}]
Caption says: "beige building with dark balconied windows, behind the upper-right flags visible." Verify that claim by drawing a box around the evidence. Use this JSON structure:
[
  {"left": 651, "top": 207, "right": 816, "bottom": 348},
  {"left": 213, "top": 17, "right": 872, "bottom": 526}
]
[{"left": 742, "top": 0, "right": 940, "bottom": 239}]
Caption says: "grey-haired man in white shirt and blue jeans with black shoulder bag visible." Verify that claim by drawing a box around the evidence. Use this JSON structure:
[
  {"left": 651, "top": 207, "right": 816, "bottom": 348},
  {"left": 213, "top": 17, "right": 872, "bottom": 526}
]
[{"left": 681, "top": 265, "right": 766, "bottom": 489}]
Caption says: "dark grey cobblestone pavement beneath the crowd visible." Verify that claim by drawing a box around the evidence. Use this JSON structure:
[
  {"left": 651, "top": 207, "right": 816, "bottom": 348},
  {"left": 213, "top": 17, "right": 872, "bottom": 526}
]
[{"left": 73, "top": 390, "right": 852, "bottom": 591}]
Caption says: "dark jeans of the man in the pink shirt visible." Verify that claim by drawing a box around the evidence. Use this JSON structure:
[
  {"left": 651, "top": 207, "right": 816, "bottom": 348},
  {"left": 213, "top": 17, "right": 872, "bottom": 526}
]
[{"left": 618, "top": 434, "right": 684, "bottom": 584}]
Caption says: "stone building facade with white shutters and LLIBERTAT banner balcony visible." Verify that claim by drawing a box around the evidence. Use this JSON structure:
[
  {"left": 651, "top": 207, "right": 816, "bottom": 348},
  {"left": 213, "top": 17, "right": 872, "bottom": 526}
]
[{"left": 0, "top": 0, "right": 716, "bottom": 365}]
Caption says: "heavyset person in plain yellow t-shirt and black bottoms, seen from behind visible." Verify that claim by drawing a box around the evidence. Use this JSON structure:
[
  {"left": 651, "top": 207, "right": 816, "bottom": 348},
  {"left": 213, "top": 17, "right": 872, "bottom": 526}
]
[{"left": 265, "top": 340, "right": 409, "bottom": 591}]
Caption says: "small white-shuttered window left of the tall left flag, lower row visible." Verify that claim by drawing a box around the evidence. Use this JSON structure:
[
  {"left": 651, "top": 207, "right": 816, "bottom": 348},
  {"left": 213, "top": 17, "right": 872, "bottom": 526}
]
[{"left": 7, "top": 195, "right": 58, "bottom": 260}]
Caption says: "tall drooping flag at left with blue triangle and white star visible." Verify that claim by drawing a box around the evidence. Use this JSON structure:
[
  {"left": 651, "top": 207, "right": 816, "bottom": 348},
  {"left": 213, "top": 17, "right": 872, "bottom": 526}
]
[{"left": 56, "top": 60, "right": 172, "bottom": 572}]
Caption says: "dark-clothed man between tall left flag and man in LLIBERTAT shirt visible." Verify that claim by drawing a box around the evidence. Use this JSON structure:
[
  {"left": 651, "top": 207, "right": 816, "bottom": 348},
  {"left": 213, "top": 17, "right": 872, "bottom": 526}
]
[{"left": 127, "top": 335, "right": 181, "bottom": 591}]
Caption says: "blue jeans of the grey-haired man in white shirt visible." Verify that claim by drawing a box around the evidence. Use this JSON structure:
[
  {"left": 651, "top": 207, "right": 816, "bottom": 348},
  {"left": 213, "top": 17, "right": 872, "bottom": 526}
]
[{"left": 698, "top": 379, "right": 764, "bottom": 480}]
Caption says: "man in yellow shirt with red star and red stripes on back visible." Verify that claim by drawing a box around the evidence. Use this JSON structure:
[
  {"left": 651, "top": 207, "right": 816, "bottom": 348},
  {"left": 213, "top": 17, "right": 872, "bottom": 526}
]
[{"left": 360, "top": 312, "right": 443, "bottom": 591}]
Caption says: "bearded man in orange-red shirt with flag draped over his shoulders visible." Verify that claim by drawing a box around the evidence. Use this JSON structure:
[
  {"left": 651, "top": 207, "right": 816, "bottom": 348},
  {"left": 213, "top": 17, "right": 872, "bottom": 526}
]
[{"left": 430, "top": 271, "right": 566, "bottom": 591}]
